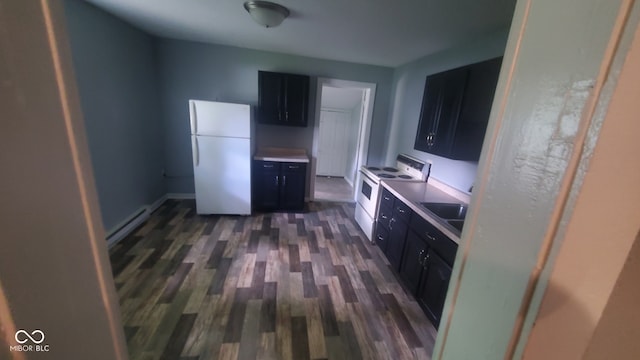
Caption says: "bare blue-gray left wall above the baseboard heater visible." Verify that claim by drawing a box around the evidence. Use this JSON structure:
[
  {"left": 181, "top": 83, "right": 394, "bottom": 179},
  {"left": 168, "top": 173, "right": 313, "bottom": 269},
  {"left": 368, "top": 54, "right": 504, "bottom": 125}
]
[{"left": 64, "top": 0, "right": 166, "bottom": 231}]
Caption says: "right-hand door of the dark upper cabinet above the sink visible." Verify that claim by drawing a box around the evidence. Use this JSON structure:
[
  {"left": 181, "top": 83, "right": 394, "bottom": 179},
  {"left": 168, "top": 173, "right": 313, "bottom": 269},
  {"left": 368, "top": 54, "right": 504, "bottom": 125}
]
[{"left": 451, "top": 57, "right": 502, "bottom": 161}]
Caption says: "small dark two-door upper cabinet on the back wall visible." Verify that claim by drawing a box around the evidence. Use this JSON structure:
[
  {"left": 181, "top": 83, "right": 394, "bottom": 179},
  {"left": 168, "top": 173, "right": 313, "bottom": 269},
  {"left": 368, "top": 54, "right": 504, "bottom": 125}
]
[{"left": 258, "top": 71, "right": 309, "bottom": 126}]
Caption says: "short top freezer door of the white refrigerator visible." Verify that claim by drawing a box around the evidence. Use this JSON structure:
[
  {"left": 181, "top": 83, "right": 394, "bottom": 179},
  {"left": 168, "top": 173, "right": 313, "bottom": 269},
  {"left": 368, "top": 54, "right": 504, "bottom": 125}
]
[{"left": 189, "top": 100, "right": 251, "bottom": 138}]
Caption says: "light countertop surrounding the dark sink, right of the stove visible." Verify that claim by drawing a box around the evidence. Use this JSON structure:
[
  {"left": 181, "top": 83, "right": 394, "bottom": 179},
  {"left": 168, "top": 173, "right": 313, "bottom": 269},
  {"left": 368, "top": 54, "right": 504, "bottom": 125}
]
[{"left": 381, "top": 180, "right": 468, "bottom": 244}]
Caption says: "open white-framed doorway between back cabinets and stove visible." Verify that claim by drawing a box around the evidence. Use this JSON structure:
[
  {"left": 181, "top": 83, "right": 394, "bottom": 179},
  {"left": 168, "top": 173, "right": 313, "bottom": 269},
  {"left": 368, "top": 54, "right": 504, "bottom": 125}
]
[{"left": 311, "top": 79, "right": 375, "bottom": 202}]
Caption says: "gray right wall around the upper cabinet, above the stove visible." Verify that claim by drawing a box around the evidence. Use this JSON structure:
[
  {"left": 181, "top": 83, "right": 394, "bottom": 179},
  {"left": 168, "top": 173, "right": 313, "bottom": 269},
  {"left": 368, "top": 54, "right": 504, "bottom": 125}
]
[{"left": 384, "top": 29, "right": 508, "bottom": 191}]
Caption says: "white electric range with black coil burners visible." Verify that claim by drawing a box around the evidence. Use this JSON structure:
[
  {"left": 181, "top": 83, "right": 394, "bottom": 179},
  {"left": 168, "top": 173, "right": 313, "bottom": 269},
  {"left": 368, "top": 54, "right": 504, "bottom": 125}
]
[{"left": 355, "top": 154, "right": 431, "bottom": 241}]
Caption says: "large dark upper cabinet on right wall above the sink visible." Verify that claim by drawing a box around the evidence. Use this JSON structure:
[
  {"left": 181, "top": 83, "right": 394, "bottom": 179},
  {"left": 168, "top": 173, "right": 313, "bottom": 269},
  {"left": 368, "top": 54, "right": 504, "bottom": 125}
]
[{"left": 414, "top": 57, "right": 502, "bottom": 161}]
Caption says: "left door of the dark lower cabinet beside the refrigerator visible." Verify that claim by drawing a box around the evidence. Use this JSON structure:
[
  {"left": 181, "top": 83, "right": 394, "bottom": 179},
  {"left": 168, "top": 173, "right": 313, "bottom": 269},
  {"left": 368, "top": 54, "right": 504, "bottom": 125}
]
[{"left": 253, "top": 161, "right": 280, "bottom": 209}]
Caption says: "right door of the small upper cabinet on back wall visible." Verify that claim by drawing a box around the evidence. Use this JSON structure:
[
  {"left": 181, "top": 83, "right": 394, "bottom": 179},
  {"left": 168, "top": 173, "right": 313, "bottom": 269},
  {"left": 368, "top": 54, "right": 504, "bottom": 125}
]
[{"left": 281, "top": 74, "right": 309, "bottom": 126}]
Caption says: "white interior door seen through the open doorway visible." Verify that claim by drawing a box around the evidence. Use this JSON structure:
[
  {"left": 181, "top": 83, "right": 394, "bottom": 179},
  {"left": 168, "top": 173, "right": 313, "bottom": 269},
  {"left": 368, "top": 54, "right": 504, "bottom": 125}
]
[{"left": 316, "top": 110, "right": 351, "bottom": 177}]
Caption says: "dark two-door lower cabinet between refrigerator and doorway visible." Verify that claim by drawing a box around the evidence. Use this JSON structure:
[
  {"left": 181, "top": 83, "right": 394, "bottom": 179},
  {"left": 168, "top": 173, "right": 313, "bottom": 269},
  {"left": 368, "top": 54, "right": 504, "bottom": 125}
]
[{"left": 253, "top": 161, "right": 307, "bottom": 210}]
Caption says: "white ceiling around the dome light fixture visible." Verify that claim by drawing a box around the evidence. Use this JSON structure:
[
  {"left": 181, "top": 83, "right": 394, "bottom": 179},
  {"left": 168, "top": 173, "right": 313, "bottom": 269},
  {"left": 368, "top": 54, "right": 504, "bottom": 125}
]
[{"left": 88, "top": 0, "right": 516, "bottom": 67}]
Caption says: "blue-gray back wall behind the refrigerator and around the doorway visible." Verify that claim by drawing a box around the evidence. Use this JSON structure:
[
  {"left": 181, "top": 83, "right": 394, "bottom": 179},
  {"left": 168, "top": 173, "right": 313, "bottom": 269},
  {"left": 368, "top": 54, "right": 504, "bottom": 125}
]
[{"left": 158, "top": 39, "right": 393, "bottom": 193}]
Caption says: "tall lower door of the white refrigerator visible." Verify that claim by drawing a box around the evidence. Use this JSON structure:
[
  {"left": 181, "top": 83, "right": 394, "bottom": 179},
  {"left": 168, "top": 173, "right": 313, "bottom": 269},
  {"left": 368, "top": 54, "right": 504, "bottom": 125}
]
[{"left": 191, "top": 135, "right": 251, "bottom": 215}]
